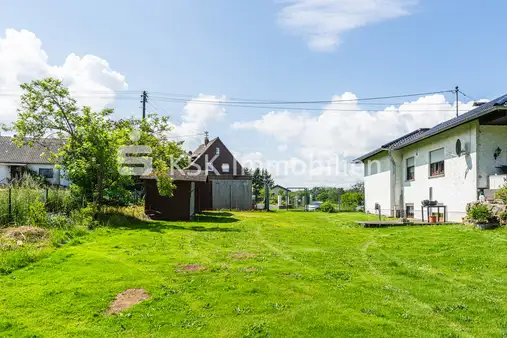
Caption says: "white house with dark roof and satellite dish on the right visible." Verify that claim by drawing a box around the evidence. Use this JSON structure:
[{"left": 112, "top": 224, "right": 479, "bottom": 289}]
[{"left": 355, "top": 95, "right": 507, "bottom": 221}]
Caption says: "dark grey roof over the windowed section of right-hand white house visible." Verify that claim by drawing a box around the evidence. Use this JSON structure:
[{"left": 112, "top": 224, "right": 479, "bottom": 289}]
[{"left": 393, "top": 94, "right": 507, "bottom": 149}]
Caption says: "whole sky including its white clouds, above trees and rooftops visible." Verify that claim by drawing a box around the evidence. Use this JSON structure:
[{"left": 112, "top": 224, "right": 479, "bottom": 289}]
[{"left": 0, "top": 0, "right": 507, "bottom": 187}]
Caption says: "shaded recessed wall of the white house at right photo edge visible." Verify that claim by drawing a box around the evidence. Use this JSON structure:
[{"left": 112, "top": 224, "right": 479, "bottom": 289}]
[{"left": 477, "top": 125, "right": 507, "bottom": 189}]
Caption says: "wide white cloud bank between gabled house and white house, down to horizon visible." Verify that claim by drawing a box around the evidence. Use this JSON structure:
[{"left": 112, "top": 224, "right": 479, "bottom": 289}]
[{"left": 232, "top": 93, "right": 484, "bottom": 187}]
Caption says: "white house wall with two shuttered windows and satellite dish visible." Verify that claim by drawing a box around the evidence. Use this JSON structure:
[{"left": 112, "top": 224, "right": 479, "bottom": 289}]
[{"left": 400, "top": 121, "right": 478, "bottom": 221}]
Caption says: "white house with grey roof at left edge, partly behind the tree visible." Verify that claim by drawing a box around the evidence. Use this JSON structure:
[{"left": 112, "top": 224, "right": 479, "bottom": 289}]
[{"left": 0, "top": 136, "right": 69, "bottom": 186}]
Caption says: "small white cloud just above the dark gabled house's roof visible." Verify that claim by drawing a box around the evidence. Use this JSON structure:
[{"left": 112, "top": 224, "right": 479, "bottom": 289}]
[{"left": 170, "top": 94, "right": 226, "bottom": 150}]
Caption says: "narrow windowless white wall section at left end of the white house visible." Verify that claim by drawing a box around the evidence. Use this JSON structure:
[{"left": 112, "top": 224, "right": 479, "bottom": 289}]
[{"left": 364, "top": 152, "right": 394, "bottom": 216}]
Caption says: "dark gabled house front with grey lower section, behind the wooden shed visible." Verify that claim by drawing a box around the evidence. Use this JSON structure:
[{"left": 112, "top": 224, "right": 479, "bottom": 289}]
[{"left": 187, "top": 136, "right": 252, "bottom": 210}]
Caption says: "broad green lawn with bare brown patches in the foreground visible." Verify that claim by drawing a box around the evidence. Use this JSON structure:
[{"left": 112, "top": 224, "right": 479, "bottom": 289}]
[{"left": 0, "top": 211, "right": 507, "bottom": 337}]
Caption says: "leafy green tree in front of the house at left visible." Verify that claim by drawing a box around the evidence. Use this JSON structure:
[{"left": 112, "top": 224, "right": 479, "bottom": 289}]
[{"left": 11, "top": 78, "right": 184, "bottom": 207}]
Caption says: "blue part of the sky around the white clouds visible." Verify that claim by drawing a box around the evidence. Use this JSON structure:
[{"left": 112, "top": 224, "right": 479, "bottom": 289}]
[{"left": 0, "top": 0, "right": 507, "bottom": 185}]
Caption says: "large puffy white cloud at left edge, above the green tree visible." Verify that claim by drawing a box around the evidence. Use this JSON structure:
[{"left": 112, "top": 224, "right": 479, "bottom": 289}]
[{"left": 0, "top": 29, "right": 127, "bottom": 122}]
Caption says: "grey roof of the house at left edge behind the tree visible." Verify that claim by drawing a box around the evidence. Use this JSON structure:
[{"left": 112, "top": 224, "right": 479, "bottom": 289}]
[{"left": 0, "top": 136, "right": 65, "bottom": 164}]
